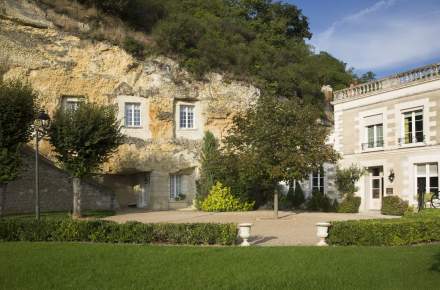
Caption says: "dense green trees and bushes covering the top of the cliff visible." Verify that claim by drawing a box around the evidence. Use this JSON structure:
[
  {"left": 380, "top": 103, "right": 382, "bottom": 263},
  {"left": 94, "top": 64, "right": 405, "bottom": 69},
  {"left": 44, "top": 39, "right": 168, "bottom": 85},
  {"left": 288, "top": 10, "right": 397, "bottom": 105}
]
[{"left": 69, "top": 0, "right": 355, "bottom": 104}]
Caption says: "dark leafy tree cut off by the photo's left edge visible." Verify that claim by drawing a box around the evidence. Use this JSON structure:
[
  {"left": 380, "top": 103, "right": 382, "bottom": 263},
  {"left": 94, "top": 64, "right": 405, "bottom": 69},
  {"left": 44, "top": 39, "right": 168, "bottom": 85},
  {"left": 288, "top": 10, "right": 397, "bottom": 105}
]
[{"left": 0, "top": 81, "right": 37, "bottom": 215}]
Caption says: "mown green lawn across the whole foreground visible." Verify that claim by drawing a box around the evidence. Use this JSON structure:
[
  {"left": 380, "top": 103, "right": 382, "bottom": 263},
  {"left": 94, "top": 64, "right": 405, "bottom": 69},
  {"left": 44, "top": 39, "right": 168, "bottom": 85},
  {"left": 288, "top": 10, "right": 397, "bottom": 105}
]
[{"left": 0, "top": 242, "right": 440, "bottom": 290}]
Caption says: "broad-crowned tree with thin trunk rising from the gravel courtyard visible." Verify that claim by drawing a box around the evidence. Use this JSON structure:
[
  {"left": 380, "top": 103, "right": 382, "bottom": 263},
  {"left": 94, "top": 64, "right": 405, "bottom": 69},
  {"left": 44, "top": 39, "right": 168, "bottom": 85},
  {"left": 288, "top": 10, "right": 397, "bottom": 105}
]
[{"left": 225, "top": 96, "right": 338, "bottom": 217}]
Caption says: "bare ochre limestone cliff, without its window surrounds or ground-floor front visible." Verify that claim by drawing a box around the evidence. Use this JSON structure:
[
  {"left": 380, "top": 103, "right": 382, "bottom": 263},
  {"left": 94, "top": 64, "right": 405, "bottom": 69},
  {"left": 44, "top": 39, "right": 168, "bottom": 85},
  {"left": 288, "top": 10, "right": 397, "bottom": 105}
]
[{"left": 0, "top": 0, "right": 259, "bottom": 173}]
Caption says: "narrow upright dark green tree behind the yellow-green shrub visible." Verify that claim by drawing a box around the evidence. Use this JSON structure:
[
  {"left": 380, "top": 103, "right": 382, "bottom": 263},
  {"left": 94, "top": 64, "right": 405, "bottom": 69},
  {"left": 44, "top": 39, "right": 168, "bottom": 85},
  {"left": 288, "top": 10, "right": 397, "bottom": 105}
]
[{"left": 197, "top": 131, "right": 220, "bottom": 201}]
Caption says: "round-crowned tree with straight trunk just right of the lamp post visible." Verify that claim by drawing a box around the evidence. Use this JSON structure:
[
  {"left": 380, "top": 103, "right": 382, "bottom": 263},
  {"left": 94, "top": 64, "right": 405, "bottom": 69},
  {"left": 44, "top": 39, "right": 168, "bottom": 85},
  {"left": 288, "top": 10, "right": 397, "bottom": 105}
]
[{"left": 48, "top": 104, "right": 123, "bottom": 218}]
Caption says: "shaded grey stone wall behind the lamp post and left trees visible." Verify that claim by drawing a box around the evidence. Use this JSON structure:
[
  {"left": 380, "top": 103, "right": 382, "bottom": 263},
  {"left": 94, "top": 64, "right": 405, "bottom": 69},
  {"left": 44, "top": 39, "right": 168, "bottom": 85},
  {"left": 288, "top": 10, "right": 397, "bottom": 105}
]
[{"left": 4, "top": 149, "right": 118, "bottom": 214}]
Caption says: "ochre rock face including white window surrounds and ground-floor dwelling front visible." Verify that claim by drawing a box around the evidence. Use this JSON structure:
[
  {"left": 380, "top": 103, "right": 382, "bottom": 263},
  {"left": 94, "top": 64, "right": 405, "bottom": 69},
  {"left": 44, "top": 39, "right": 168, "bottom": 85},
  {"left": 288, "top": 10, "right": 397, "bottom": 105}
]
[{"left": 0, "top": 0, "right": 259, "bottom": 209}]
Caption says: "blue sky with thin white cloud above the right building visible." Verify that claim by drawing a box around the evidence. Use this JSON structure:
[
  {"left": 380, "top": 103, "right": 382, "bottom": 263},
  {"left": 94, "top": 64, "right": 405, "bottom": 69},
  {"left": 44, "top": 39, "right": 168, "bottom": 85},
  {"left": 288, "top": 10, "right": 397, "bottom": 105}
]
[{"left": 287, "top": 0, "right": 440, "bottom": 77}]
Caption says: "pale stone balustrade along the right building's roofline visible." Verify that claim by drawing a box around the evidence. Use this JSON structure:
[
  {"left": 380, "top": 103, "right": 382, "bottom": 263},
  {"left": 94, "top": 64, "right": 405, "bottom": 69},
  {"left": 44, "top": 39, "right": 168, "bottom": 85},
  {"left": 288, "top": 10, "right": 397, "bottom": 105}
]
[{"left": 334, "top": 63, "right": 440, "bottom": 102}]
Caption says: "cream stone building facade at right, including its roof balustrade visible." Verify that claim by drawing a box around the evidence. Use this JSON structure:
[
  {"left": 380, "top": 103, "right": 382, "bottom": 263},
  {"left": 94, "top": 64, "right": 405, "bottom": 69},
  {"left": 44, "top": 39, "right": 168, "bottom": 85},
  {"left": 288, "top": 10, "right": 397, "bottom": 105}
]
[{"left": 333, "top": 64, "right": 440, "bottom": 211}]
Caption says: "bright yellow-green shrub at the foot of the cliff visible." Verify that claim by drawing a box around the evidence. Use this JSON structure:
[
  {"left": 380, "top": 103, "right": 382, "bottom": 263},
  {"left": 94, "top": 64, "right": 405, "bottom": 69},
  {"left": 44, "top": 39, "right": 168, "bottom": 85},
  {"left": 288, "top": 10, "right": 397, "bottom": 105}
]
[{"left": 202, "top": 182, "right": 255, "bottom": 211}]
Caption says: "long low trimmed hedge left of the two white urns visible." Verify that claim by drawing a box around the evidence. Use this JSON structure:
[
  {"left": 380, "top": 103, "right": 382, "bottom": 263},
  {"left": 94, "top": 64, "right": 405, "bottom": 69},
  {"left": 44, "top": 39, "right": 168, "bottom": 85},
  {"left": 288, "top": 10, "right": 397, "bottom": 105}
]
[{"left": 0, "top": 219, "right": 237, "bottom": 245}]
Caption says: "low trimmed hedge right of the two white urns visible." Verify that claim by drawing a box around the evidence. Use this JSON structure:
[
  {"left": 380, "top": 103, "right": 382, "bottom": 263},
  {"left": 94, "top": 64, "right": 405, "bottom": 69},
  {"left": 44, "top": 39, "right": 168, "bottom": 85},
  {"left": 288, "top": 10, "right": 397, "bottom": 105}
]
[{"left": 327, "top": 218, "right": 440, "bottom": 246}]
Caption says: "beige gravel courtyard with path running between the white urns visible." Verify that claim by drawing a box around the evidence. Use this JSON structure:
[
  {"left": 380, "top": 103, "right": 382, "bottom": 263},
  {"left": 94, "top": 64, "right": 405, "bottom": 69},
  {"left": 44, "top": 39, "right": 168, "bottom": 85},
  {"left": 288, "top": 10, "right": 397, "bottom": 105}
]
[{"left": 106, "top": 210, "right": 398, "bottom": 246}]
